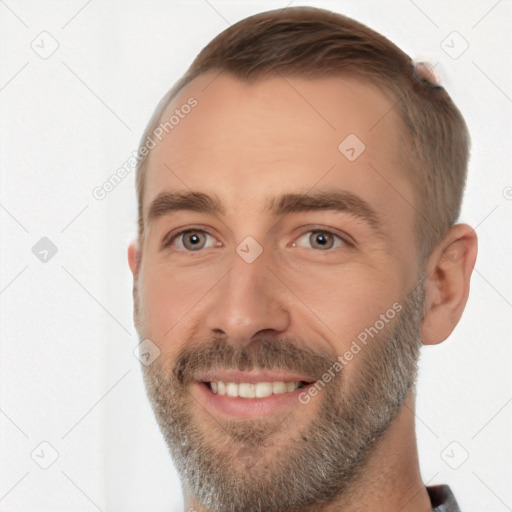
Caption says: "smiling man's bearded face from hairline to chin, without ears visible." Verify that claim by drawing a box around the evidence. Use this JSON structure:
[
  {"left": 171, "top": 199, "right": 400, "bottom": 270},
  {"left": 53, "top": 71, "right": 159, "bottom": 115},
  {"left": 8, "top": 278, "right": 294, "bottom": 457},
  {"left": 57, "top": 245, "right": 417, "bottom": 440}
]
[{"left": 131, "top": 74, "right": 423, "bottom": 511}]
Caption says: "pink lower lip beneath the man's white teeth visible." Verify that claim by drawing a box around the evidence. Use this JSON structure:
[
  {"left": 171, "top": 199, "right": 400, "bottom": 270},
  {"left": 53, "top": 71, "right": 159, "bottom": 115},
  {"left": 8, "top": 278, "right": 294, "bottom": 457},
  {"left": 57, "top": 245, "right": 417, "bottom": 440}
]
[{"left": 194, "top": 382, "right": 314, "bottom": 418}]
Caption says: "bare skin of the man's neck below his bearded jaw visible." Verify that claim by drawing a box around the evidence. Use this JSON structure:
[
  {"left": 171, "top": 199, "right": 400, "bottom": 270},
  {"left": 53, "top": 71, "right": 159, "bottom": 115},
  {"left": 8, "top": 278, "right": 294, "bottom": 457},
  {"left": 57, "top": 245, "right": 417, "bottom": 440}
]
[{"left": 182, "top": 392, "right": 432, "bottom": 512}]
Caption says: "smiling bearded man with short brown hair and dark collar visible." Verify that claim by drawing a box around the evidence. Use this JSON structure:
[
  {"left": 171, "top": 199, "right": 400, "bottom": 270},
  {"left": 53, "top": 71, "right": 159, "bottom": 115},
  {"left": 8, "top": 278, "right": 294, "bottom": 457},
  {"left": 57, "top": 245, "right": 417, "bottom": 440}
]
[{"left": 128, "top": 7, "right": 477, "bottom": 512}]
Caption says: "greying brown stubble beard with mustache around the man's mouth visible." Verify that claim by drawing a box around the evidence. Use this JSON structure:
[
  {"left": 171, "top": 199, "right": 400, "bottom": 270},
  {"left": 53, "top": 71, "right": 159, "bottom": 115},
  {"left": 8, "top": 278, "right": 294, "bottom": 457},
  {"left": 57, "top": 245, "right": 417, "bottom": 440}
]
[{"left": 141, "top": 279, "right": 424, "bottom": 512}]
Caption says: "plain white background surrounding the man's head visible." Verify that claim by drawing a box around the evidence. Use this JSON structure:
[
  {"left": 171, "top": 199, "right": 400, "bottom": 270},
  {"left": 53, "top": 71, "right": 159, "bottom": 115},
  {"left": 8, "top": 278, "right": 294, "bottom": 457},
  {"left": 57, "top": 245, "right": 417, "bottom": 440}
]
[{"left": 0, "top": 0, "right": 512, "bottom": 512}]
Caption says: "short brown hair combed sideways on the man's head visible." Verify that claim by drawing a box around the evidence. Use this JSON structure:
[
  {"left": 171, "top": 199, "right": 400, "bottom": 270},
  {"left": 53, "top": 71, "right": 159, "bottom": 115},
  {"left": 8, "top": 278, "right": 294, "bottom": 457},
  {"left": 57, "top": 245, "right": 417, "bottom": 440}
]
[{"left": 136, "top": 7, "right": 470, "bottom": 261}]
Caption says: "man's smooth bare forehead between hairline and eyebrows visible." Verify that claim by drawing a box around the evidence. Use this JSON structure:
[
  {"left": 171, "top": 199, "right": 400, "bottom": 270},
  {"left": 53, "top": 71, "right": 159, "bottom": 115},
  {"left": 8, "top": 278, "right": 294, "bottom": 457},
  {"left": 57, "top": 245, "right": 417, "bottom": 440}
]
[{"left": 144, "top": 73, "right": 414, "bottom": 248}]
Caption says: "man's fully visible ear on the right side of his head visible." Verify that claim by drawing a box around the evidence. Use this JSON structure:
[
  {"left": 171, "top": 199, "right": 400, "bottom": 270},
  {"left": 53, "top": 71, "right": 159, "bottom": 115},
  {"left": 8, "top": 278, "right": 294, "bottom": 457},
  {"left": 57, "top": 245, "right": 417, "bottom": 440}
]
[{"left": 421, "top": 224, "right": 478, "bottom": 345}]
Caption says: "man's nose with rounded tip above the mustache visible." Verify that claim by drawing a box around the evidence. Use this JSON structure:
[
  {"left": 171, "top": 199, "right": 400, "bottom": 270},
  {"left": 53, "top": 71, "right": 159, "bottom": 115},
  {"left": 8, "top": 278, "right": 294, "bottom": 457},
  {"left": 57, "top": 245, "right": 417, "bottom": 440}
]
[{"left": 206, "top": 254, "right": 290, "bottom": 345}]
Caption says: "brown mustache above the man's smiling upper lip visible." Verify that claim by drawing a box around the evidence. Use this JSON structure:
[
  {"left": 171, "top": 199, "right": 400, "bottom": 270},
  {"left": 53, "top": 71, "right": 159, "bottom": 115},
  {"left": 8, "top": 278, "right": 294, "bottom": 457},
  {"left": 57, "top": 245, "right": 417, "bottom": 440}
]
[{"left": 173, "top": 336, "right": 337, "bottom": 385}]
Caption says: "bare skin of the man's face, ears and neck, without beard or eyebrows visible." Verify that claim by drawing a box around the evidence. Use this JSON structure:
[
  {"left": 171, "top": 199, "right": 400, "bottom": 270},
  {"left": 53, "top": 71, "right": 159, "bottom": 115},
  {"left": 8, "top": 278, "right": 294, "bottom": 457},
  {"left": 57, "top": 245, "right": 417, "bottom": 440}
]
[{"left": 128, "top": 73, "right": 477, "bottom": 512}]
